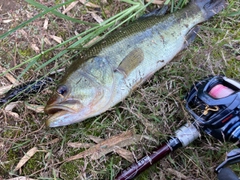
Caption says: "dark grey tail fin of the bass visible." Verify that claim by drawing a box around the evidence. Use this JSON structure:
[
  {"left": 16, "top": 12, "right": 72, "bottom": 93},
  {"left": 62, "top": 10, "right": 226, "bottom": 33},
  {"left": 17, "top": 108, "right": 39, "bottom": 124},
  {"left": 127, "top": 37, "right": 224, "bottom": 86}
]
[{"left": 193, "top": 0, "right": 227, "bottom": 19}]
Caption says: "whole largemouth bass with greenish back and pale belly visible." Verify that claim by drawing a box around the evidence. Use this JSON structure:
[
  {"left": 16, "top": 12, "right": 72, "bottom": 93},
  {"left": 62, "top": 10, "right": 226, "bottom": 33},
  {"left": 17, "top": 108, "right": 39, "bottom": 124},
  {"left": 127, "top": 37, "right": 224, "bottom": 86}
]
[{"left": 45, "top": 0, "right": 225, "bottom": 127}]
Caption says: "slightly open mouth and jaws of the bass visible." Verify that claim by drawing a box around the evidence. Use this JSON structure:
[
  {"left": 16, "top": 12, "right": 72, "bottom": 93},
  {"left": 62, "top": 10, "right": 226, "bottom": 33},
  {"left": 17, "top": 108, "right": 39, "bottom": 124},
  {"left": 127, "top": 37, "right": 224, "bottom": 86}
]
[{"left": 44, "top": 100, "right": 83, "bottom": 127}]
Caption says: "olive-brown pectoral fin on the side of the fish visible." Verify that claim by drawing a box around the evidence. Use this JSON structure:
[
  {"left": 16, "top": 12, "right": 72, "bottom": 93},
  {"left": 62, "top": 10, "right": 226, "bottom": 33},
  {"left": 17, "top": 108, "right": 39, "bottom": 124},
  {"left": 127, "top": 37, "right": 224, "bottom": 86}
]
[{"left": 115, "top": 48, "right": 144, "bottom": 77}]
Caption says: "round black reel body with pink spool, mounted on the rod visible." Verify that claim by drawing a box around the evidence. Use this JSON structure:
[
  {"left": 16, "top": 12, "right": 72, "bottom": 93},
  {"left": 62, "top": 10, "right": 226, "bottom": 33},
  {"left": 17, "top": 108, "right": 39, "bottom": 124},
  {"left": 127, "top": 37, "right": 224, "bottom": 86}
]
[{"left": 185, "top": 76, "right": 240, "bottom": 142}]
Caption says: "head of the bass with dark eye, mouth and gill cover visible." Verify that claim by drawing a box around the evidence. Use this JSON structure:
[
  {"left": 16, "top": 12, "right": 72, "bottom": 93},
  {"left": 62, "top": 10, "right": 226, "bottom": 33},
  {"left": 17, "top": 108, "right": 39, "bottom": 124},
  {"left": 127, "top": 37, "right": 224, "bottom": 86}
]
[{"left": 44, "top": 74, "right": 106, "bottom": 127}]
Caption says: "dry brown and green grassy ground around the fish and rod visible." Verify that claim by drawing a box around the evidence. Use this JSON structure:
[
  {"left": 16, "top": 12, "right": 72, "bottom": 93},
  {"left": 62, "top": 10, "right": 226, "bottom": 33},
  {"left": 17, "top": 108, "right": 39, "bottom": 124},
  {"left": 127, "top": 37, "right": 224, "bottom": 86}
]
[{"left": 0, "top": 0, "right": 240, "bottom": 180}]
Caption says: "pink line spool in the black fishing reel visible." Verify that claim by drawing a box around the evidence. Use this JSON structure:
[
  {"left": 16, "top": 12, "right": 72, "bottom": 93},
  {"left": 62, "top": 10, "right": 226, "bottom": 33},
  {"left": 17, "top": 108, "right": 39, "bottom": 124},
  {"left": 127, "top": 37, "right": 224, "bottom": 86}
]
[{"left": 209, "top": 84, "right": 234, "bottom": 98}]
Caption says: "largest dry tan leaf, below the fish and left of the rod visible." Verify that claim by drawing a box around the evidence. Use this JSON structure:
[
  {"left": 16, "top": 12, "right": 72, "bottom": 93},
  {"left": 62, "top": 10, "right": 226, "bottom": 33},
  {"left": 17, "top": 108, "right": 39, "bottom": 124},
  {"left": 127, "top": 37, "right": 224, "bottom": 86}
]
[{"left": 65, "top": 131, "right": 141, "bottom": 162}]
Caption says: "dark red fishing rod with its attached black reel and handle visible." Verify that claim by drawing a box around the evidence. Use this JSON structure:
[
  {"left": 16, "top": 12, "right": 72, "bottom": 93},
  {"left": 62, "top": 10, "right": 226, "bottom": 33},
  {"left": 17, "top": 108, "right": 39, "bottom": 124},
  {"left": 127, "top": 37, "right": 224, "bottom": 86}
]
[{"left": 116, "top": 76, "right": 240, "bottom": 180}]
